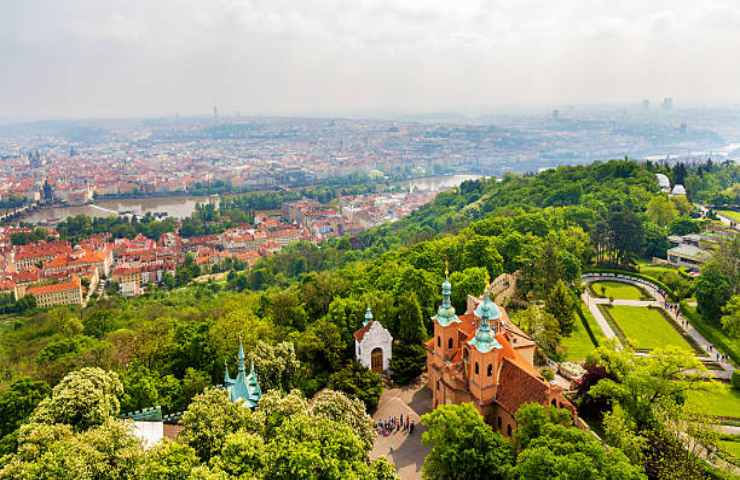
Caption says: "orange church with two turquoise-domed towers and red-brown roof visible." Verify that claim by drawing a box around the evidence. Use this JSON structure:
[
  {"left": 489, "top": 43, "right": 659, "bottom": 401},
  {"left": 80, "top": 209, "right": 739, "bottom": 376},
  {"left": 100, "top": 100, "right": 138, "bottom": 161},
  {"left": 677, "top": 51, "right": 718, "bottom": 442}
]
[{"left": 426, "top": 279, "right": 576, "bottom": 436}]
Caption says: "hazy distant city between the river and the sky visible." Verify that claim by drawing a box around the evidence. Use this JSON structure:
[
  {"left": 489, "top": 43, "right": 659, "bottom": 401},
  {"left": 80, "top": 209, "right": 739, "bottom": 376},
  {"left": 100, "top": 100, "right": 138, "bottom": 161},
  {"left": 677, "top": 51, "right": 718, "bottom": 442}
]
[{"left": 0, "top": 106, "right": 740, "bottom": 218}]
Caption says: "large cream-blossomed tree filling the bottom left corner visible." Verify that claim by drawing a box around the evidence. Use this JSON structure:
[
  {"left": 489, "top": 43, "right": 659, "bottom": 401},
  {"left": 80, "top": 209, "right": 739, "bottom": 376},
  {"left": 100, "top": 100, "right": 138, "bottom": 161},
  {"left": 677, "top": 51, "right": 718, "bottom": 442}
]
[{"left": 0, "top": 368, "right": 143, "bottom": 480}]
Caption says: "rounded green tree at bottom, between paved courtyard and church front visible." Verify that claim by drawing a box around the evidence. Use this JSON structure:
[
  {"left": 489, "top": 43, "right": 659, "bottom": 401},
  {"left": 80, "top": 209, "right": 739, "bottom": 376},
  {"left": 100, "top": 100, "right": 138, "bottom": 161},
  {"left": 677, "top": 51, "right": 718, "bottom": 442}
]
[{"left": 421, "top": 403, "right": 513, "bottom": 480}]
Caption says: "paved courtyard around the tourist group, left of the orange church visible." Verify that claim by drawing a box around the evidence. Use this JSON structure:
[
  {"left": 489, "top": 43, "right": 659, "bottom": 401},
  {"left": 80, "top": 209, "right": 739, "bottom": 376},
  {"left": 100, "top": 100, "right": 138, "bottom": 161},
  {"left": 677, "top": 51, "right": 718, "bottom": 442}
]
[{"left": 370, "top": 375, "right": 432, "bottom": 480}]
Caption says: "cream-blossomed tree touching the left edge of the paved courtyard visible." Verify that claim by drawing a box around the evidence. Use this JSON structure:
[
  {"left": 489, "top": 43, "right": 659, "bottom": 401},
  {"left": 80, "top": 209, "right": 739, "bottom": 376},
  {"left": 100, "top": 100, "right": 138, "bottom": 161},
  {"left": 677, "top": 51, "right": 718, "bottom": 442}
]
[{"left": 311, "top": 390, "right": 375, "bottom": 448}]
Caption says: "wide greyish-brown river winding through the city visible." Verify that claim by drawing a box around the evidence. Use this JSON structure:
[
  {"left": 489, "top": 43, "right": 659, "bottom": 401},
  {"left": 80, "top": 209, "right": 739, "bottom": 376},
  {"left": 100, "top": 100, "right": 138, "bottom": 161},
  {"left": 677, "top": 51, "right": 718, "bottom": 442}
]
[{"left": 22, "top": 175, "right": 480, "bottom": 224}]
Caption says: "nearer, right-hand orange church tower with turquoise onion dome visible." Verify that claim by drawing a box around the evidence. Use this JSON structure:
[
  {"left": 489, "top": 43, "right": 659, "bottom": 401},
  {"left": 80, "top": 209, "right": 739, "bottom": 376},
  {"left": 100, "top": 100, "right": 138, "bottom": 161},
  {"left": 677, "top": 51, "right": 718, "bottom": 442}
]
[{"left": 463, "top": 289, "right": 503, "bottom": 404}]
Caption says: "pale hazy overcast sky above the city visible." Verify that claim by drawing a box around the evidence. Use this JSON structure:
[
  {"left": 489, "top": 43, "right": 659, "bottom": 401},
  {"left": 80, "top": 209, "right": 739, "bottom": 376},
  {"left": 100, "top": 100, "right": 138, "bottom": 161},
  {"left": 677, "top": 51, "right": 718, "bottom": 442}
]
[{"left": 0, "top": 0, "right": 740, "bottom": 118}]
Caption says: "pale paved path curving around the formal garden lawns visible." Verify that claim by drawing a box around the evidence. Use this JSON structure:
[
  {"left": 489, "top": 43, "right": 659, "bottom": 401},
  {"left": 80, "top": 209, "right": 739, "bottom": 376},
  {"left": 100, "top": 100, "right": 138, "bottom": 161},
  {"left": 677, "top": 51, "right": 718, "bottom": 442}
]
[{"left": 582, "top": 276, "right": 734, "bottom": 380}]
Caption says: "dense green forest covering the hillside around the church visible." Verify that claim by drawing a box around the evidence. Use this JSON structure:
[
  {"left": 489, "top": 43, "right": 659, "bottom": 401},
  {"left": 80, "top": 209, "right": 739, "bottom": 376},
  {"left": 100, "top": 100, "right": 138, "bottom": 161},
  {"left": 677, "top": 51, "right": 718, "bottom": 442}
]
[{"left": 0, "top": 160, "right": 740, "bottom": 479}]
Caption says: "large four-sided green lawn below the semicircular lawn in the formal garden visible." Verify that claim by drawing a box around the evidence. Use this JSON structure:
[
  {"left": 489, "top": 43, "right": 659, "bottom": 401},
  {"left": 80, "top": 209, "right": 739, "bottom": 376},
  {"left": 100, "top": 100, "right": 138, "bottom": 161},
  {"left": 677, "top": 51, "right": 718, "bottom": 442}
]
[{"left": 599, "top": 305, "right": 694, "bottom": 351}]
